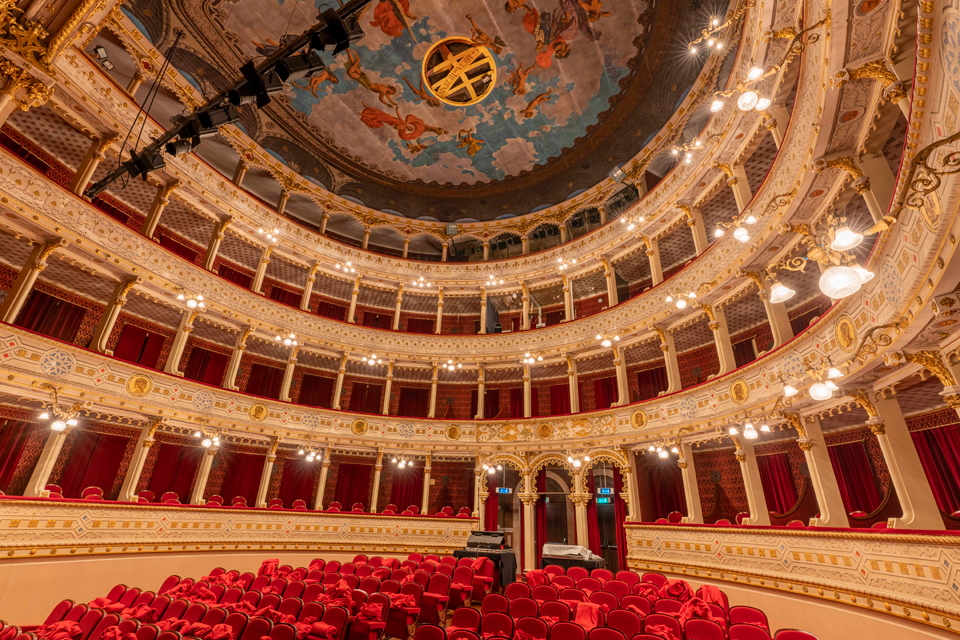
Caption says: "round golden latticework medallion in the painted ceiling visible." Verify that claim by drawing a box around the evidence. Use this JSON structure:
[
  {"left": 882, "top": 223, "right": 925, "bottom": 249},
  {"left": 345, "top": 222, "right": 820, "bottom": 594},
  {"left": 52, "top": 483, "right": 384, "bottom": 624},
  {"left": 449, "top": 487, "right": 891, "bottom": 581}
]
[{"left": 422, "top": 36, "right": 497, "bottom": 107}]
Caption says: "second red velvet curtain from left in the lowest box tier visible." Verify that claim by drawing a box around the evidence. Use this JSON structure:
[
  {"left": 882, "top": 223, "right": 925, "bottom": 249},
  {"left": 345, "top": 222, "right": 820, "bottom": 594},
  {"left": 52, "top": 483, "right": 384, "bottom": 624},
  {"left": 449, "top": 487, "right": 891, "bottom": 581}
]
[{"left": 60, "top": 431, "right": 130, "bottom": 498}]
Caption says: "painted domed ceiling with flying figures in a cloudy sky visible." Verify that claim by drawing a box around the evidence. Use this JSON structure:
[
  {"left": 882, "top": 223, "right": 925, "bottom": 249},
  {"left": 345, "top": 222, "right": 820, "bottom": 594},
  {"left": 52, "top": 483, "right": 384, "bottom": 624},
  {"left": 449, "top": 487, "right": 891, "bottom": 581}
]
[{"left": 125, "top": 0, "right": 703, "bottom": 220}]
